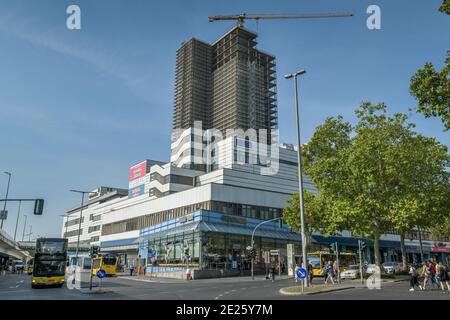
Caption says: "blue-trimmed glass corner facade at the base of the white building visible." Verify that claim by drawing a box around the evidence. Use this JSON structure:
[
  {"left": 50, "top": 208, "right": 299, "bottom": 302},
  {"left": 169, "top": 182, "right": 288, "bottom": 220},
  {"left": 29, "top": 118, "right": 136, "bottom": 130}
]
[{"left": 140, "top": 210, "right": 300, "bottom": 272}]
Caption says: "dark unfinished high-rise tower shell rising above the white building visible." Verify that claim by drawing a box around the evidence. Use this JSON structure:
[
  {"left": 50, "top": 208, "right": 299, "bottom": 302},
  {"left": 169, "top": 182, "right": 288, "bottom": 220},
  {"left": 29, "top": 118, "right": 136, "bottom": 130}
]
[{"left": 173, "top": 27, "right": 278, "bottom": 144}]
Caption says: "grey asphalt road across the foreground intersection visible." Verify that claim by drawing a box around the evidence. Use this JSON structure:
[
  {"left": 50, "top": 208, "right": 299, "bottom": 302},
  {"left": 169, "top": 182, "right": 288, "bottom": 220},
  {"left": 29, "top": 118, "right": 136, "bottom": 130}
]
[{"left": 0, "top": 274, "right": 450, "bottom": 301}]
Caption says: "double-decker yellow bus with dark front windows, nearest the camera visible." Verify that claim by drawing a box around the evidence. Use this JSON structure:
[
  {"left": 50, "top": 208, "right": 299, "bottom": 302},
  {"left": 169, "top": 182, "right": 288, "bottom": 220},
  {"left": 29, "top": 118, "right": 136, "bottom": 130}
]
[{"left": 31, "top": 238, "right": 67, "bottom": 288}]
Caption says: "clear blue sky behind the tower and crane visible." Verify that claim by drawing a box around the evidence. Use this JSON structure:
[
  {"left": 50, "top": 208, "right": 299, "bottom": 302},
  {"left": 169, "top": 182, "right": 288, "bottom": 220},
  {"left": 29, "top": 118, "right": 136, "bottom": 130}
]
[{"left": 0, "top": 0, "right": 450, "bottom": 238}]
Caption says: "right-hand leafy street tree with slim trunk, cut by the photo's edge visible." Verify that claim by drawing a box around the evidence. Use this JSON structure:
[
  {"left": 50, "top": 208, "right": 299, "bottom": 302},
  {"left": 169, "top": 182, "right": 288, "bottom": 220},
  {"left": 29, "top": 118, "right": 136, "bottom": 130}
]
[{"left": 390, "top": 132, "right": 450, "bottom": 268}]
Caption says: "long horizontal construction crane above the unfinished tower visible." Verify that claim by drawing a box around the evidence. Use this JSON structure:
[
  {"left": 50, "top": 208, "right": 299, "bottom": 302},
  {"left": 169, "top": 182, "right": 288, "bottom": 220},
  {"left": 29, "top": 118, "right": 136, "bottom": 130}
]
[{"left": 208, "top": 13, "right": 354, "bottom": 27}]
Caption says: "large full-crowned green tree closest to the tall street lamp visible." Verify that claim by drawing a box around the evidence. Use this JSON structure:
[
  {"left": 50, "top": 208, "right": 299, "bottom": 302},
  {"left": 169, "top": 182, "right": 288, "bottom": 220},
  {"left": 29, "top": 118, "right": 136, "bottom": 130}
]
[{"left": 285, "top": 103, "right": 448, "bottom": 265}]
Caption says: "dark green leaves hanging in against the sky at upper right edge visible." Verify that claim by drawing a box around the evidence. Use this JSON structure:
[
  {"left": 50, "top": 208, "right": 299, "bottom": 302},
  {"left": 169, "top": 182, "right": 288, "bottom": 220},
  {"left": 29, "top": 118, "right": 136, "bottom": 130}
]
[{"left": 410, "top": 51, "right": 450, "bottom": 130}]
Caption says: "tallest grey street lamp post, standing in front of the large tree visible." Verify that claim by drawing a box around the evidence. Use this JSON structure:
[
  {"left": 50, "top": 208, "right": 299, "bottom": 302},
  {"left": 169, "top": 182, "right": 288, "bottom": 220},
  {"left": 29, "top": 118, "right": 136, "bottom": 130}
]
[{"left": 284, "top": 69, "right": 308, "bottom": 286}]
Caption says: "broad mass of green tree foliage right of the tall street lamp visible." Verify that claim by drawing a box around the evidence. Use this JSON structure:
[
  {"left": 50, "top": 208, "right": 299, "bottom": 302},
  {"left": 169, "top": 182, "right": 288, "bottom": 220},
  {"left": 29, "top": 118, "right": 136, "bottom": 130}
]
[{"left": 285, "top": 103, "right": 450, "bottom": 263}]
